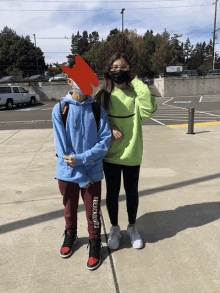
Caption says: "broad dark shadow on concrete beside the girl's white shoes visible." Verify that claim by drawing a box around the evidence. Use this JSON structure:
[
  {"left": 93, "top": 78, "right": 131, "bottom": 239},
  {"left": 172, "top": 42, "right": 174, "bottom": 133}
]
[{"left": 136, "top": 202, "right": 220, "bottom": 243}]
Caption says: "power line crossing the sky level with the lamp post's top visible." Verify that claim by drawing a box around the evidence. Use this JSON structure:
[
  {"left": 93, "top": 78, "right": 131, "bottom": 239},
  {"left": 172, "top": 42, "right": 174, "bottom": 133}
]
[{"left": 0, "top": 4, "right": 211, "bottom": 12}]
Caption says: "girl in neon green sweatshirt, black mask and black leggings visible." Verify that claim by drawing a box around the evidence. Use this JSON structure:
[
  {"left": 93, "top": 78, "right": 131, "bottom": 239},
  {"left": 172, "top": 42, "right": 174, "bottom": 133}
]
[{"left": 94, "top": 53, "right": 157, "bottom": 249}]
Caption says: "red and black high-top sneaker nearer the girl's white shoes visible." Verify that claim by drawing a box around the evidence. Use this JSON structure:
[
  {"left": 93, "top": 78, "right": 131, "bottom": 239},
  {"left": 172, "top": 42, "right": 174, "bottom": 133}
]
[{"left": 87, "top": 238, "right": 101, "bottom": 270}]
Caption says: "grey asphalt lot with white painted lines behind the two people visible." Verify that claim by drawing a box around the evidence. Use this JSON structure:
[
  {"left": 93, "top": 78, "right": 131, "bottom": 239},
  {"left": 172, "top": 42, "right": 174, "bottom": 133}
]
[{"left": 0, "top": 93, "right": 220, "bottom": 130}]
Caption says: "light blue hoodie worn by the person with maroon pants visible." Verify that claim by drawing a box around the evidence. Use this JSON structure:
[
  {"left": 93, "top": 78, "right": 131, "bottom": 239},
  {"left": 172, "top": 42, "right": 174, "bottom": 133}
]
[{"left": 52, "top": 93, "right": 111, "bottom": 188}]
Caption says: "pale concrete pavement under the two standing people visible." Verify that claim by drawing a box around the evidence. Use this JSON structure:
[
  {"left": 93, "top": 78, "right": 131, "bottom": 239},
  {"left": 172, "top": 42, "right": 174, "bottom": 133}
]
[{"left": 0, "top": 125, "right": 220, "bottom": 293}]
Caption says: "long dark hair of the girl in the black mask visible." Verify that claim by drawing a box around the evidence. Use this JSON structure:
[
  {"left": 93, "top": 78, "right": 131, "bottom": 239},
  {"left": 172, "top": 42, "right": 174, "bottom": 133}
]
[{"left": 94, "top": 52, "right": 131, "bottom": 110}]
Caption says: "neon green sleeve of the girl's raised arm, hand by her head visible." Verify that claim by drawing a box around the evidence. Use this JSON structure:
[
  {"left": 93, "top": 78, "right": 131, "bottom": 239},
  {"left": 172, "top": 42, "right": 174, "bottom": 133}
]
[{"left": 131, "top": 78, "right": 157, "bottom": 121}]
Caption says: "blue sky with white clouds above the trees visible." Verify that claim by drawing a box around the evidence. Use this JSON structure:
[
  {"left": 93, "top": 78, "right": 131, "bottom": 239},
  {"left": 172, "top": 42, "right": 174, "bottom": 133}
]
[{"left": 0, "top": 0, "right": 220, "bottom": 63}]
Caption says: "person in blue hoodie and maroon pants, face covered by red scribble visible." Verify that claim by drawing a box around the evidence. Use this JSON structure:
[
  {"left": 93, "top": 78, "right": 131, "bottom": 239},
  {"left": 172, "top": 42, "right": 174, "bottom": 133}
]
[{"left": 52, "top": 70, "right": 111, "bottom": 270}]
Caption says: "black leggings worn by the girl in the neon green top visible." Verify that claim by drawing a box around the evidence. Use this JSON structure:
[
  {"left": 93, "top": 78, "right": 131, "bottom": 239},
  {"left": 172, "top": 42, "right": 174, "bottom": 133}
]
[{"left": 103, "top": 161, "right": 140, "bottom": 226}]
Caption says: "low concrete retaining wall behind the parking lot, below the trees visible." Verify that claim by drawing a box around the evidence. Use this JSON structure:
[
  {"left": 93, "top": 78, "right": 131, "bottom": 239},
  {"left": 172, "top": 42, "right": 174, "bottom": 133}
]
[{"left": 0, "top": 76, "right": 220, "bottom": 100}]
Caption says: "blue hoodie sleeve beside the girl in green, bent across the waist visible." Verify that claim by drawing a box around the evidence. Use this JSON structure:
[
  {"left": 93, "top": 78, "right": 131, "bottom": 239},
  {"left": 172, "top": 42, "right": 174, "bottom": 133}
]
[{"left": 74, "top": 106, "right": 112, "bottom": 166}]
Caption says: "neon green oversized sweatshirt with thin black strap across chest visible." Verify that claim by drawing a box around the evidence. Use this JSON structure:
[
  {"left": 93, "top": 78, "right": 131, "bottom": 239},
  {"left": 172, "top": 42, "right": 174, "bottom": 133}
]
[{"left": 93, "top": 78, "right": 157, "bottom": 166}]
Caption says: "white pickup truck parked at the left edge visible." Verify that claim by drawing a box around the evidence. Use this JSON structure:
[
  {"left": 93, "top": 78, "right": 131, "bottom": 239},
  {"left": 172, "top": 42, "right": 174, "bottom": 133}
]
[{"left": 0, "top": 86, "right": 36, "bottom": 110}]
